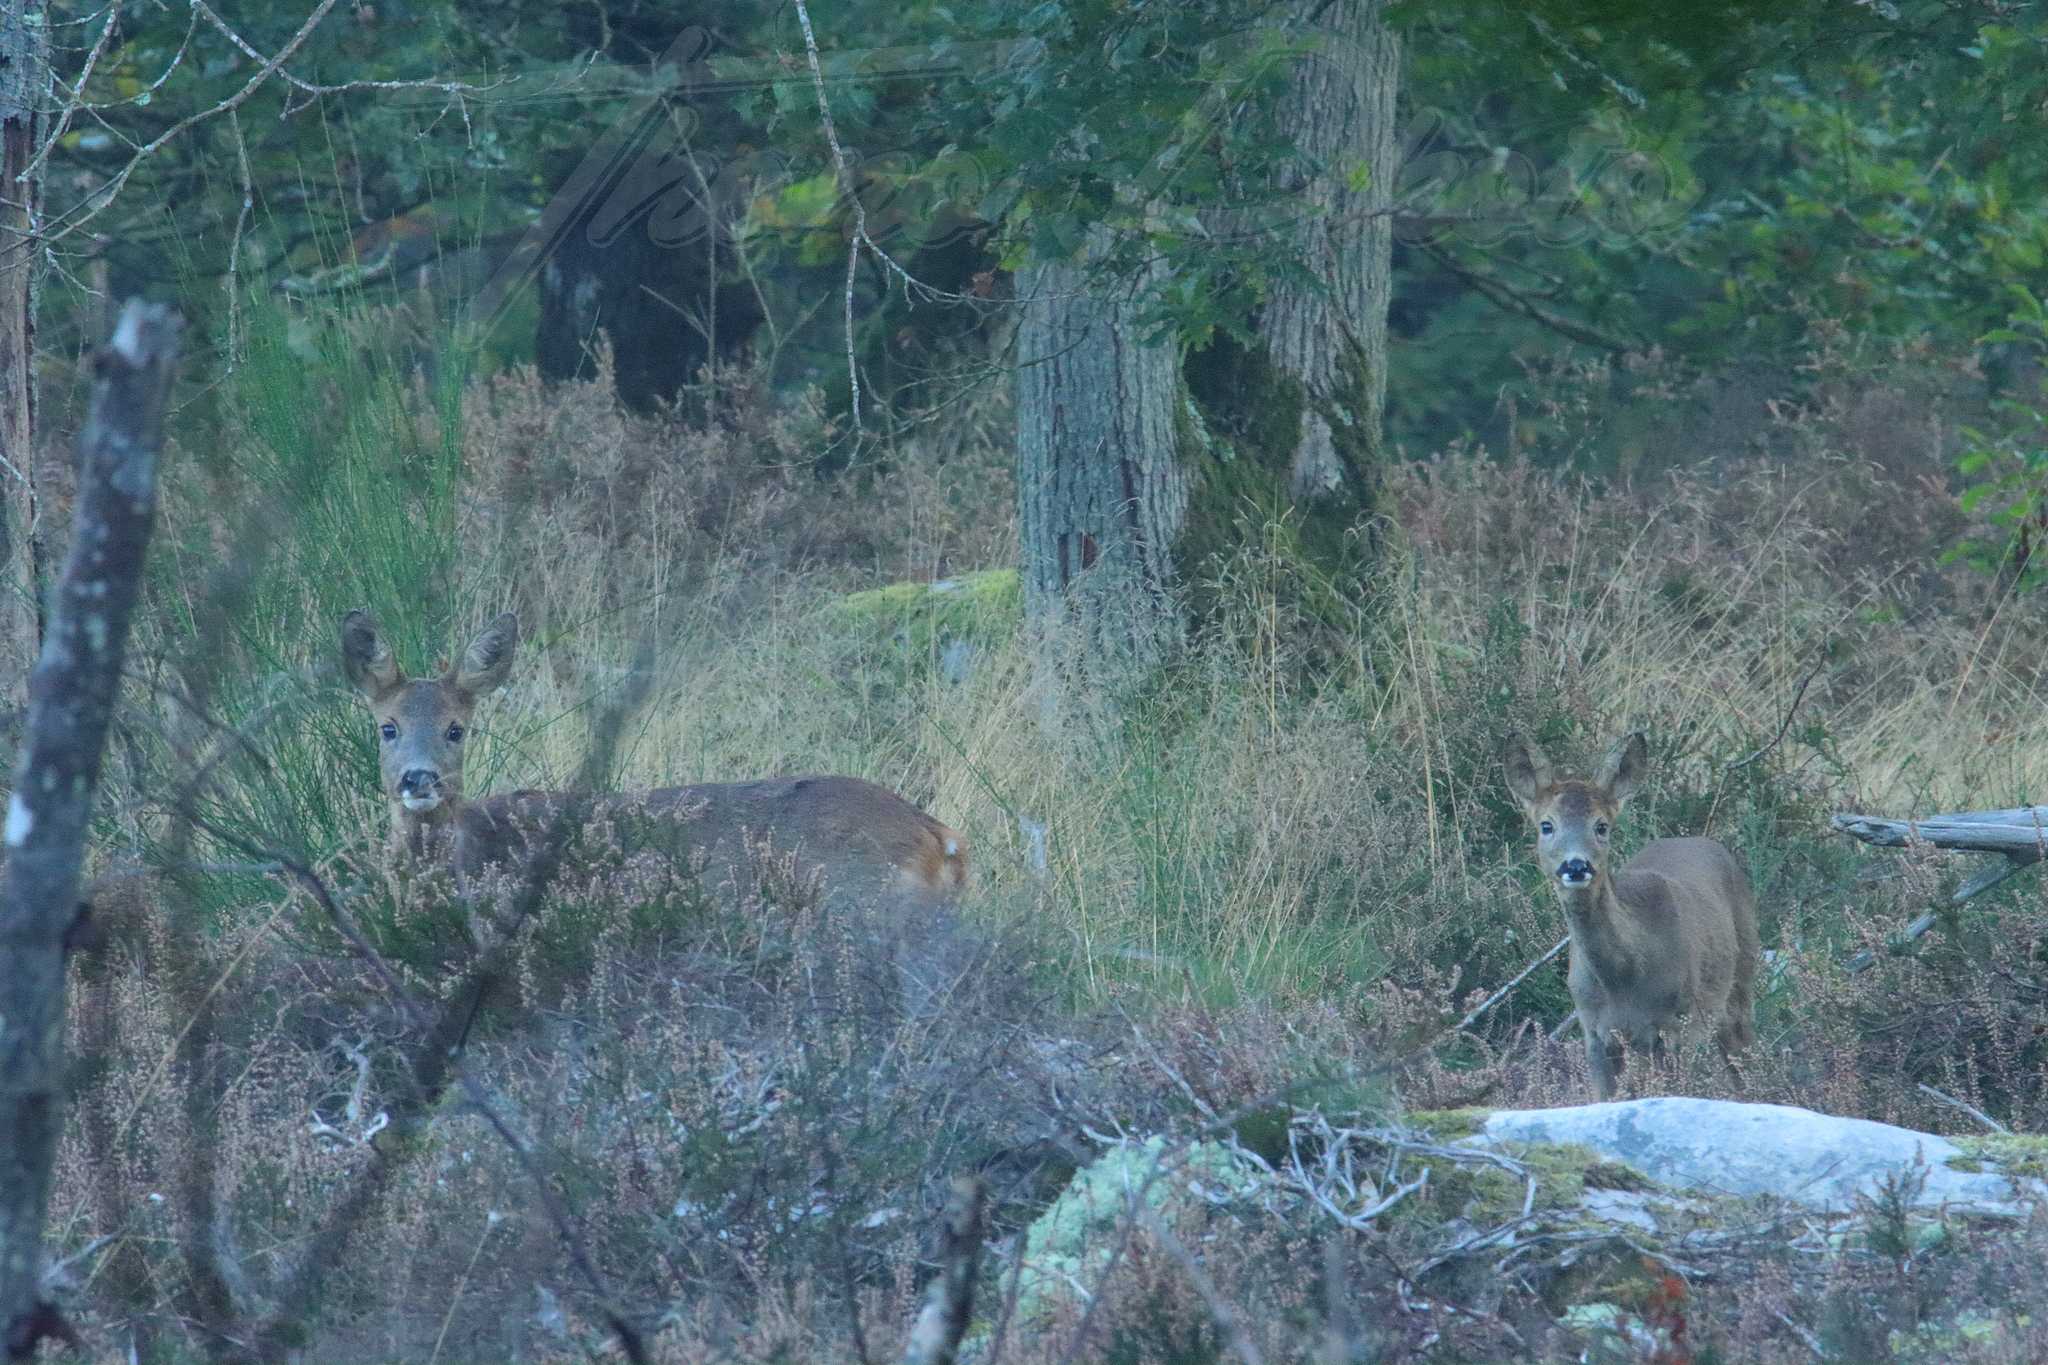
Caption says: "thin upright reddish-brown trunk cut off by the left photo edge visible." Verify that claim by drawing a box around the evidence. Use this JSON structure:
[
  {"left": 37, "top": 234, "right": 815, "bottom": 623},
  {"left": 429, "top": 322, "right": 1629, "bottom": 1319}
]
[{"left": 0, "top": 0, "right": 49, "bottom": 720}]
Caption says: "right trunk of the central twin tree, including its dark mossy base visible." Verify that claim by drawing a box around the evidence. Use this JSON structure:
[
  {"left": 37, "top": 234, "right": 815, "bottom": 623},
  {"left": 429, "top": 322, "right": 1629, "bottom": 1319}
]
[{"left": 1180, "top": 0, "right": 1401, "bottom": 642}]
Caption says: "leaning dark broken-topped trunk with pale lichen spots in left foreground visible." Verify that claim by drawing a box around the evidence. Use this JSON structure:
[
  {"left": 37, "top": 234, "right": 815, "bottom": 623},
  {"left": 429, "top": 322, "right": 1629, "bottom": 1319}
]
[{"left": 0, "top": 301, "right": 178, "bottom": 1359}]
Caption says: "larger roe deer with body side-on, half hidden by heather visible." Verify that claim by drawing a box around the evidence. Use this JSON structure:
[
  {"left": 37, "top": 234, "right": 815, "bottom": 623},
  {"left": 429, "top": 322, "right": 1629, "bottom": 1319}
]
[{"left": 342, "top": 612, "right": 967, "bottom": 902}]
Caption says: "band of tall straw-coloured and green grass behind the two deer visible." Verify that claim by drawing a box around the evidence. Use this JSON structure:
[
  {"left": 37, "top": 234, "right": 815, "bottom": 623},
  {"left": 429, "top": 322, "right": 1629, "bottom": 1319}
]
[{"left": 116, "top": 294, "right": 2048, "bottom": 999}]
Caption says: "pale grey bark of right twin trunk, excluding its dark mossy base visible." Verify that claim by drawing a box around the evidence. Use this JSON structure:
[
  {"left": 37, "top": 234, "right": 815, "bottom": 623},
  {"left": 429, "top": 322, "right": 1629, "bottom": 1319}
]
[{"left": 1257, "top": 0, "right": 1401, "bottom": 505}]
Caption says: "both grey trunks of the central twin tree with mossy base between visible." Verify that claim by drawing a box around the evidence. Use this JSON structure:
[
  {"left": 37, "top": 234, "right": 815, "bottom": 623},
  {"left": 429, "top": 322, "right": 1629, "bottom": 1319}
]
[{"left": 1016, "top": 0, "right": 1401, "bottom": 699}]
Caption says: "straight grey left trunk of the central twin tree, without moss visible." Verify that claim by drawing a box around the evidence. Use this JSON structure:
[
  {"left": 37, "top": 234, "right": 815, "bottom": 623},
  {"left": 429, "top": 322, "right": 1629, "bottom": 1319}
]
[{"left": 1016, "top": 241, "right": 1188, "bottom": 681}]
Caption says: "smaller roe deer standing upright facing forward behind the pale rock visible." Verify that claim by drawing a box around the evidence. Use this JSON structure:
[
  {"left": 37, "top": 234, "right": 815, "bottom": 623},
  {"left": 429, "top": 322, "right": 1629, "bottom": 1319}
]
[{"left": 1505, "top": 735, "right": 1761, "bottom": 1099}]
